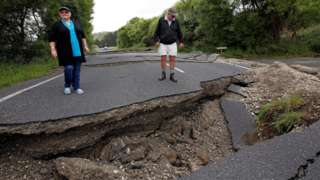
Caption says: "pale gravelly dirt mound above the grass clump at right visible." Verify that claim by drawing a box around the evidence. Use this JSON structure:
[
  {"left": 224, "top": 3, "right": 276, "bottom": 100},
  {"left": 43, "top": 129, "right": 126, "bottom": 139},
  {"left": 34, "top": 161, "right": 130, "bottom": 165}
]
[{"left": 242, "top": 62, "right": 320, "bottom": 122}]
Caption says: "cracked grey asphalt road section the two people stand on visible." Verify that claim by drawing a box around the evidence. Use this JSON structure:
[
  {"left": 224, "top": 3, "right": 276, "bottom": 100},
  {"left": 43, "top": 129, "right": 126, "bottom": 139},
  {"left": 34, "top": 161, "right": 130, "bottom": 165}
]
[{"left": 0, "top": 53, "right": 244, "bottom": 125}]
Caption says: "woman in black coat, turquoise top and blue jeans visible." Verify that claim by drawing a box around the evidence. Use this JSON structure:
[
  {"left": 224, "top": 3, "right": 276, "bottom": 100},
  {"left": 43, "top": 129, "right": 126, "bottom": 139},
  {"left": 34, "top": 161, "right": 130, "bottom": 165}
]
[{"left": 49, "top": 7, "right": 89, "bottom": 95}]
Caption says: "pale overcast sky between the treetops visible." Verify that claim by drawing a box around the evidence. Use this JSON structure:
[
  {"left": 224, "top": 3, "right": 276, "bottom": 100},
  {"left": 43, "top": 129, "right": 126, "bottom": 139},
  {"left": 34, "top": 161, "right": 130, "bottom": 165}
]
[{"left": 93, "top": 0, "right": 179, "bottom": 32}]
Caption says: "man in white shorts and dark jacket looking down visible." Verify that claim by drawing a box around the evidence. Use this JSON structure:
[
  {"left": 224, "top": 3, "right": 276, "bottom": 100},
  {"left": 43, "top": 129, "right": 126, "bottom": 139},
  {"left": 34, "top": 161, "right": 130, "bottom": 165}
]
[{"left": 154, "top": 8, "right": 184, "bottom": 83}]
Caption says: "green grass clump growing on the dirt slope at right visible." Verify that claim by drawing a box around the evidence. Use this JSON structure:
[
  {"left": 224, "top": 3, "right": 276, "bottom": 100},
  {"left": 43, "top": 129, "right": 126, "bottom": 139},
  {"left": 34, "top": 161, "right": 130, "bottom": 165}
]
[{"left": 257, "top": 96, "right": 304, "bottom": 137}]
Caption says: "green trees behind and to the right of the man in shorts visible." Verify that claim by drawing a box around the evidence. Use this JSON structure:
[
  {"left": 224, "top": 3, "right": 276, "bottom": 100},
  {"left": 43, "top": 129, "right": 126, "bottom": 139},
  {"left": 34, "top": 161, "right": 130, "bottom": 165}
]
[{"left": 114, "top": 0, "right": 320, "bottom": 56}]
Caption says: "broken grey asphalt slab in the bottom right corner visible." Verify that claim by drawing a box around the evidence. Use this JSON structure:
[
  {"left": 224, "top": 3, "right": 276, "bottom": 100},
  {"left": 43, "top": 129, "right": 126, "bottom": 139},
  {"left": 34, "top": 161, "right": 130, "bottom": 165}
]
[{"left": 180, "top": 122, "right": 320, "bottom": 180}]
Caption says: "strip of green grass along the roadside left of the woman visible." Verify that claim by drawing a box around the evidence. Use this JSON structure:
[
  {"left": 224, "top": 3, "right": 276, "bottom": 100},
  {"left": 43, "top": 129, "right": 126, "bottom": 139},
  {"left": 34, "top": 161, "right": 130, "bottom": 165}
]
[{"left": 0, "top": 60, "right": 57, "bottom": 89}]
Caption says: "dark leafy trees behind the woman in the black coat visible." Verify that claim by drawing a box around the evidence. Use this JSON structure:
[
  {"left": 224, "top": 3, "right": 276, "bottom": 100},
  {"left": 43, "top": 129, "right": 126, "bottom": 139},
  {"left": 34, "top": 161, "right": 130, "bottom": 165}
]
[{"left": 0, "top": 0, "right": 93, "bottom": 63}]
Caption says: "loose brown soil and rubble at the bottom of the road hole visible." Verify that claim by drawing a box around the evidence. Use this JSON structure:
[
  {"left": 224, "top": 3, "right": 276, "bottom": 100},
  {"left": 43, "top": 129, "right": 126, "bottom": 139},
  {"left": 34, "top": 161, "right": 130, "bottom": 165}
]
[{"left": 0, "top": 98, "right": 233, "bottom": 180}]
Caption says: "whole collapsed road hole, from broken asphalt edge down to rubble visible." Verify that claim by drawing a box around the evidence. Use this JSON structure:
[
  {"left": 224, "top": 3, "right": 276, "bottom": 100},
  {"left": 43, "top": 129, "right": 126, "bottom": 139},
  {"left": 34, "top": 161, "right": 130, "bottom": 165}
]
[{"left": 0, "top": 78, "right": 240, "bottom": 180}]
